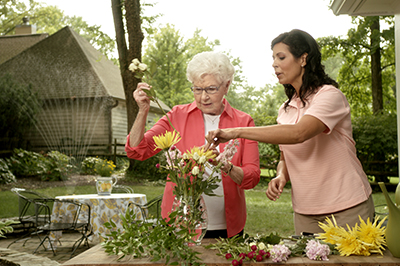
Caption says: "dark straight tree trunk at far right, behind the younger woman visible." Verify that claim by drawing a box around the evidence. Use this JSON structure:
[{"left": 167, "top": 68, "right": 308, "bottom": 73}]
[{"left": 370, "top": 17, "right": 383, "bottom": 114}]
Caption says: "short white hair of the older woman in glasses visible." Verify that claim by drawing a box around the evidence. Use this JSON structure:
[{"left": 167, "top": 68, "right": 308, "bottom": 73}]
[{"left": 186, "top": 52, "right": 235, "bottom": 83}]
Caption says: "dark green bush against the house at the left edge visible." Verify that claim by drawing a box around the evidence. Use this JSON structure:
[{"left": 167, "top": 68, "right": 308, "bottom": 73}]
[{"left": 0, "top": 74, "right": 40, "bottom": 150}]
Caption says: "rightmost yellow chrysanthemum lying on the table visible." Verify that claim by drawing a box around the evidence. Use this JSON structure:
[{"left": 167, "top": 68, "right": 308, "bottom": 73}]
[{"left": 357, "top": 216, "right": 386, "bottom": 255}]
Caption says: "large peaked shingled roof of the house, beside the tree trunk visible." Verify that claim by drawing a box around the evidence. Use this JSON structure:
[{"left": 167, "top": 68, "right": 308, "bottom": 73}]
[{"left": 0, "top": 26, "right": 125, "bottom": 100}]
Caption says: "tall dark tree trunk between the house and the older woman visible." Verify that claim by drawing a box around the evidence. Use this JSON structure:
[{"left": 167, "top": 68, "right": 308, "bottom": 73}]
[{"left": 111, "top": 0, "right": 144, "bottom": 170}]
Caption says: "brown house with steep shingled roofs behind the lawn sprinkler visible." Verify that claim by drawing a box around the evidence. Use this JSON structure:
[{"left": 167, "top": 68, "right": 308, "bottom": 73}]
[{"left": 0, "top": 23, "right": 170, "bottom": 156}]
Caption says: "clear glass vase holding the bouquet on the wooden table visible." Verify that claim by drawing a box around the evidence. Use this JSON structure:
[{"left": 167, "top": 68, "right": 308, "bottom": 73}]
[{"left": 172, "top": 195, "right": 208, "bottom": 246}]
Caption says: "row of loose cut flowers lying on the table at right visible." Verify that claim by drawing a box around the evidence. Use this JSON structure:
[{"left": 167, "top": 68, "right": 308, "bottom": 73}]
[{"left": 207, "top": 215, "right": 386, "bottom": 266}]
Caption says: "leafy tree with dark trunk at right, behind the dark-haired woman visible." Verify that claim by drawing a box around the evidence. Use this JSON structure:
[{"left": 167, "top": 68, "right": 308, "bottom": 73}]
[{"left": 318, "top": 17, "right": 395, "bottom": 116}]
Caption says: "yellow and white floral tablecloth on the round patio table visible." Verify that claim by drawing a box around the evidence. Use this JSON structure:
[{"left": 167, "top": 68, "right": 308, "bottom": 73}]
[{"left": 50, "top": 193, "right": 147, "bottom": 245}]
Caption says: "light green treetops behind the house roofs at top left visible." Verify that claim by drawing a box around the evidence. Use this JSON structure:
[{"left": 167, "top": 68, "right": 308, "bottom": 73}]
[{"left": 0, "top": 0, "right": 115, "bottom": 61}]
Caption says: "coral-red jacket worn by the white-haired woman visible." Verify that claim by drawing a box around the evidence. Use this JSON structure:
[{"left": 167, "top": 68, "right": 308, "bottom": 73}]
[{"left": 125, "top": 99, "right": 260, "bottom": 237}]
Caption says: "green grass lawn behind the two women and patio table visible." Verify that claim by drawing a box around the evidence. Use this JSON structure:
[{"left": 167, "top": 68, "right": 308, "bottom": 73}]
[{"left": 0, "top": 179, "right": 398, "bottom": 236}]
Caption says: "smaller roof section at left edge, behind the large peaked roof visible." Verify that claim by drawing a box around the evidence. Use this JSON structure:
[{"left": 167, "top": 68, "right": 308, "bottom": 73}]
[{"left": 0, "top": 33, "right": 49, "bottom": 64}]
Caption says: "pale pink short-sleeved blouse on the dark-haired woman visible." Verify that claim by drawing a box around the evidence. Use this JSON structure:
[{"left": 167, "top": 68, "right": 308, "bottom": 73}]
[{"left": 278, "top": 85, "right": 372, "bottom": 215}]
